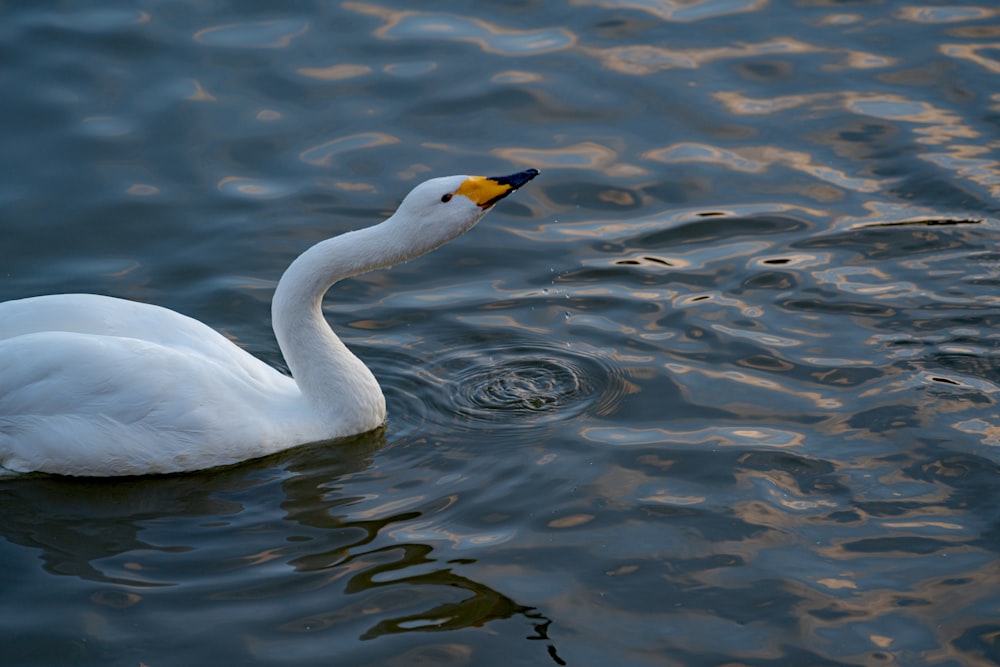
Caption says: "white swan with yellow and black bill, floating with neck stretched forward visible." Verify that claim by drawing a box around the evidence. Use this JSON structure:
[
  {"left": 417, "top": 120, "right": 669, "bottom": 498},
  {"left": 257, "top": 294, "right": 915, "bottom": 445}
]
[{"left": 0, "top": 169, "right": 538, "bottom": 476}]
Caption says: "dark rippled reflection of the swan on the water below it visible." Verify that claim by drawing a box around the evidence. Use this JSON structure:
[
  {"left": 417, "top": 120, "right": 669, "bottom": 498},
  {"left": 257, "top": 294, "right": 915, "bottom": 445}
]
[{"left": 0, "top": 435, "right": 563, "bottom": 664}]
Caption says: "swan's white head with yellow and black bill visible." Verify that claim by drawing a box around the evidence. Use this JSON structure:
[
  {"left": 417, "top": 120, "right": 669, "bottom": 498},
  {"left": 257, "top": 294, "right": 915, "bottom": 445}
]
[{"left": 393, "top": 169, "right": 538, "bottom": 247}]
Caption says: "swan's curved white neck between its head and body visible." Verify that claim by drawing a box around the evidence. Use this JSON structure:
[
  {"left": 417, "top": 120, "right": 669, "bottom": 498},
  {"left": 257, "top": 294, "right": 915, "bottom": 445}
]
[{"left": 271, "top": 223, "right": 406, "bottom": 432}]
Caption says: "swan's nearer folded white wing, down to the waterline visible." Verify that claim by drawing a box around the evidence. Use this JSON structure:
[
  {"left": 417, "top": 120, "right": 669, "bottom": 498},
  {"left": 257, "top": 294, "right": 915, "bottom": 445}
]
[{"left": 0, "top": 331, "right": 298, "bottom": 475}]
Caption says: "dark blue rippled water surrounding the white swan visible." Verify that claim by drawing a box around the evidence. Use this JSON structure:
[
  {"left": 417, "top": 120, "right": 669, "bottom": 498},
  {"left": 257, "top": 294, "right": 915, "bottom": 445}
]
[{"left": 0, "top": 0, "right": 1000, "bottom": 667}]
